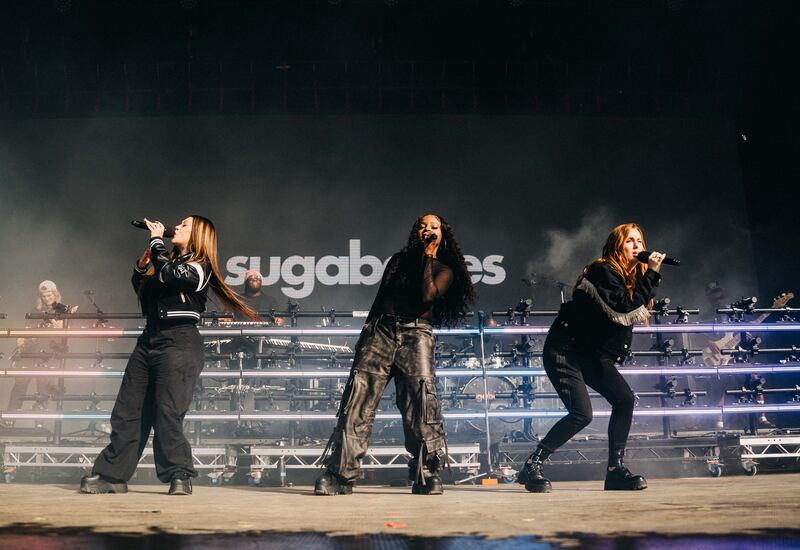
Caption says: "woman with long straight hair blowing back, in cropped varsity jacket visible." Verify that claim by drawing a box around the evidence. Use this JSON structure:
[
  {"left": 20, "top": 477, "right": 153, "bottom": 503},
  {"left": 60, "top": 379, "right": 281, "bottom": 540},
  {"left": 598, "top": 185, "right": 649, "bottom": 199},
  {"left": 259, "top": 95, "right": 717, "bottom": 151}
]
[{"left": 80, "top": 214, "right": 258, "bottom": 495}]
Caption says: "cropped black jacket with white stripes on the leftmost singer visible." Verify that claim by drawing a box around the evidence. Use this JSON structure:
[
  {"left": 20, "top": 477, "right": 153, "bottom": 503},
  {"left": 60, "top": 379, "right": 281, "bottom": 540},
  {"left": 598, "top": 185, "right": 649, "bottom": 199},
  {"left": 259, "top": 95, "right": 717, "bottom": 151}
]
[{"left": 131, "top": 237, "right": 210, "bottom": 326}]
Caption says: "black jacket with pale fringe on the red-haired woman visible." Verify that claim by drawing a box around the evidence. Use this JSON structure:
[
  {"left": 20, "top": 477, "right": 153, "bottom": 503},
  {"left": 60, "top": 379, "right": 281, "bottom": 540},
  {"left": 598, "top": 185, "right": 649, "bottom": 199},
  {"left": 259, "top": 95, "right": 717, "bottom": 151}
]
[{"left": 551, "top": 262, "right": 661, "bottom": 363}]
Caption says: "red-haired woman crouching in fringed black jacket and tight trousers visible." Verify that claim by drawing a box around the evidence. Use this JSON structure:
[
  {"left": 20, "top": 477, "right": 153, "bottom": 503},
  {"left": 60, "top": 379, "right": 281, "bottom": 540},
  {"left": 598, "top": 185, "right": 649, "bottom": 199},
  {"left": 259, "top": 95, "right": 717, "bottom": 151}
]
[{"left": 517, "top": 223, "right": 665, "bottom": 493}]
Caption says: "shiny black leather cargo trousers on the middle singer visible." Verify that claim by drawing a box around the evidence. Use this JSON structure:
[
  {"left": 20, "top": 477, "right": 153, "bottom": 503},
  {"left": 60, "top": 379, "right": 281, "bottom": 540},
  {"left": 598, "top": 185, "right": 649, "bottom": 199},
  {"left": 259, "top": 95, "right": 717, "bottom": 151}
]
[{"left": 324, "top": 315, "right": 445, "bottom": 481}]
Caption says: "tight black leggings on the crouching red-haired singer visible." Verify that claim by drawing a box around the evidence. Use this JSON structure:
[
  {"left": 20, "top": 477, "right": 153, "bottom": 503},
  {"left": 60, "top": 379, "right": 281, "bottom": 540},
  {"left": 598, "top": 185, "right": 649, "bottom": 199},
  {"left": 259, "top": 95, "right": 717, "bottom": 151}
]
[{"left": 539, "top": 336, "right": 635, "bottom": 453}]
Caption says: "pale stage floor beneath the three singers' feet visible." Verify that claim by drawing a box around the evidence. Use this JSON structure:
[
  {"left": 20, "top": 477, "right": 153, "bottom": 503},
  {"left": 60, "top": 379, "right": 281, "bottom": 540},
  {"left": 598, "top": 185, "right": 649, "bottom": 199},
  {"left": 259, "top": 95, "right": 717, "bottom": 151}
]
[{"left": 0, "top": 474, "right": 800, "bottom": 548}]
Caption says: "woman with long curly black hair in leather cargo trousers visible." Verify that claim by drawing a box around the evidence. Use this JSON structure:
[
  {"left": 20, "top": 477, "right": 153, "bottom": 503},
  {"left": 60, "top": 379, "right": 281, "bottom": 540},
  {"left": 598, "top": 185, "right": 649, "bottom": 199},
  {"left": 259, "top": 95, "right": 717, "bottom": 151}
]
[{"left": 314, "top": 214, "right": 475, "bottom": 495}]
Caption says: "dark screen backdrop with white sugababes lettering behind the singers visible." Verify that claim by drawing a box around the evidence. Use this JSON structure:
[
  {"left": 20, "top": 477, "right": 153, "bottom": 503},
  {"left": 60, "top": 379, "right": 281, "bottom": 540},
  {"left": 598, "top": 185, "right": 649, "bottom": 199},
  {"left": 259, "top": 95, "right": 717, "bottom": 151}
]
[{"left": 0, "top": 115, "right": 757, "bottom": 324}]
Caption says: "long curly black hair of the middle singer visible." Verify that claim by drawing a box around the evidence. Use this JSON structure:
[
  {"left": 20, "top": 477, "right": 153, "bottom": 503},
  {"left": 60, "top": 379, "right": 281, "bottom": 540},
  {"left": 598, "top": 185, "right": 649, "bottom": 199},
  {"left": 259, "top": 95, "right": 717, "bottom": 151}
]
[{"left": 388, "top": 214, "right": 475, "bottom": 326}]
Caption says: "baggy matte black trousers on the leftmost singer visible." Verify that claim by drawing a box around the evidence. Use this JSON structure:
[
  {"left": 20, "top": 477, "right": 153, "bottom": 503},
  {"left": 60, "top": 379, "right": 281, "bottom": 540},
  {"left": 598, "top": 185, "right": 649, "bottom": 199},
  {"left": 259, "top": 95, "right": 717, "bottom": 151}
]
[{"left": 92, "top": 325, "right": 203, "bottom": 483}]
